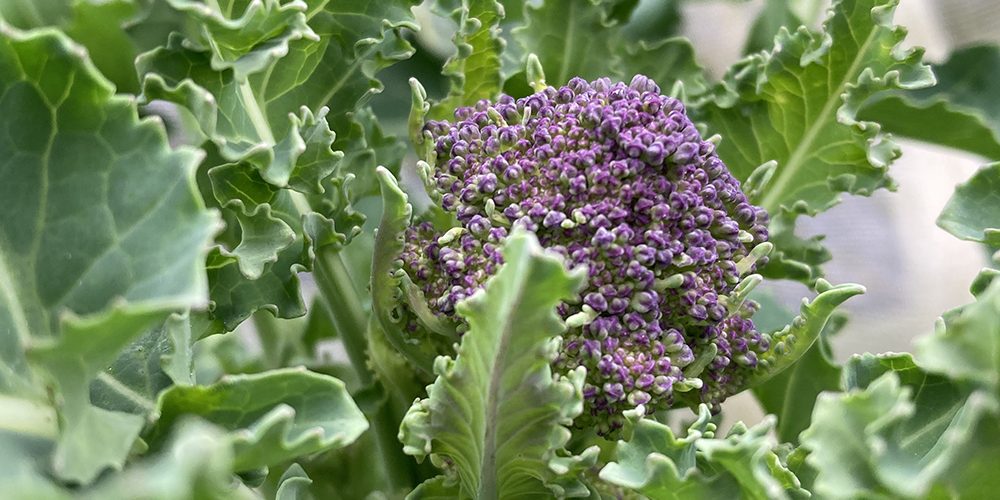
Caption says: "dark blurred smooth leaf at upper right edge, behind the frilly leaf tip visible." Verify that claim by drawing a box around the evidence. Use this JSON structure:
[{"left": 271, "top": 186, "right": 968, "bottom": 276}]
[{"left": 859, "top": 45, "right": 1000, "bottom": 160}]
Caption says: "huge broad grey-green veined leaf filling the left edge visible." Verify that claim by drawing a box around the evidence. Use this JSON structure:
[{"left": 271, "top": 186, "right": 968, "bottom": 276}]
[{"left": 0, "top": 20, "right": 216, "bottom": 372}]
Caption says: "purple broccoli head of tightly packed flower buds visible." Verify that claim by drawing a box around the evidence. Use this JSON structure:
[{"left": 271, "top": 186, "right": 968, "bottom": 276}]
[{"left": 402, "top": 76, "right": 768, "bottom": 434}]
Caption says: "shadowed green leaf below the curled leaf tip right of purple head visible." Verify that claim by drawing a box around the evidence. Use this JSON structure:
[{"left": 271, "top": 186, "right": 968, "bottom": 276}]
[{"left": 753, "top": 310, "right": 844, "bottom": 443}]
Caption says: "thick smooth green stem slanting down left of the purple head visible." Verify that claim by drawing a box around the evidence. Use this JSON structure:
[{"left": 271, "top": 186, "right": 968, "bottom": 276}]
[{"left": 313, "top": 250, "right": 419, "bottom": 492}]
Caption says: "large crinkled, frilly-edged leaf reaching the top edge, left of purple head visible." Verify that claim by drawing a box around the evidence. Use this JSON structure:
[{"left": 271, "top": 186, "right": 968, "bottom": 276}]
[{"left": 137, "top": 0, "right": 416, "bottom": 332}]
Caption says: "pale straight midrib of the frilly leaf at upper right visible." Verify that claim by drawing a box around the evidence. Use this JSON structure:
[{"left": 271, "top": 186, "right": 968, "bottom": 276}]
[{"left": 760, "top": 25, "right": 879, "bottom": 213}]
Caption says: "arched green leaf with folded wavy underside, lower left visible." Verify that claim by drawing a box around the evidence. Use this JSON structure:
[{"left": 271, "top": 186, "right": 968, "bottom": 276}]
[{"left": 156, "top": 368, "right": 368, "bottom": 471}]
